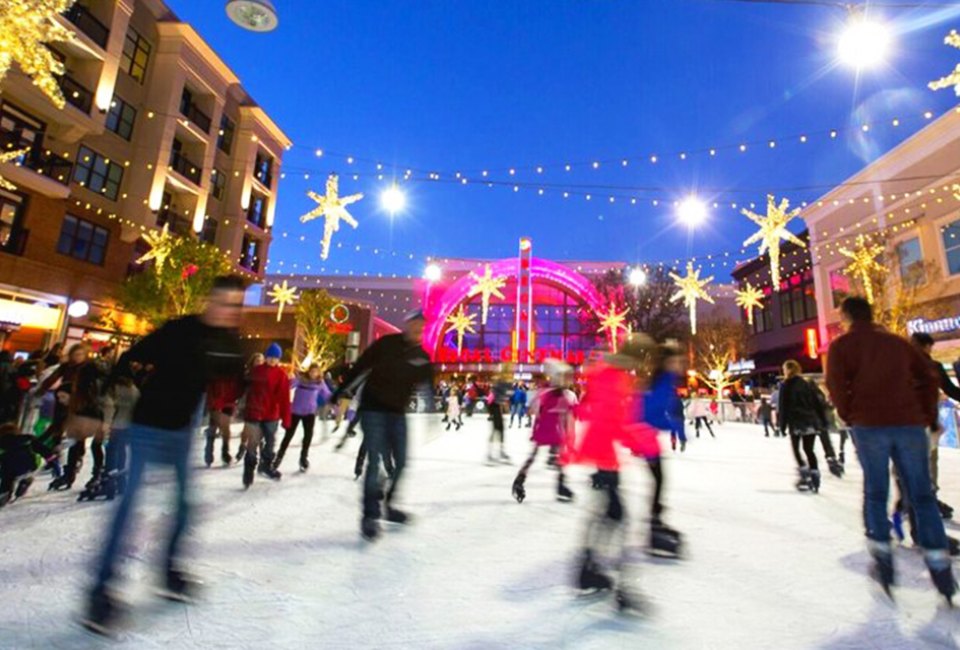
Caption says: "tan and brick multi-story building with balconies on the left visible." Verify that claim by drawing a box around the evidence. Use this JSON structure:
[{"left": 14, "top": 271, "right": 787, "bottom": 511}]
[{"left": 0, "top": 0, "right": 290, "bottom": 351}]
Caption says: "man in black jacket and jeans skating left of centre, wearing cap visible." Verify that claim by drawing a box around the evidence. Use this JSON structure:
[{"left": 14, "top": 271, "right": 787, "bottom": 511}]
[{"left": 331, "top": 312, "right": 433, "bottom": 541}]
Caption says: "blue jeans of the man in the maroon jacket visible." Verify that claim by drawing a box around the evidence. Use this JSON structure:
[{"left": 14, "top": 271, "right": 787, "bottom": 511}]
[{"left": 853, "top": 426, "right": 947, "bottom": 550}]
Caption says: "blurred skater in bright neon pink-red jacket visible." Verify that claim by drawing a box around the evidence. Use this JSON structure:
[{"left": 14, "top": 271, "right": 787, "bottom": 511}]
[{"left": 574, "top": 334, "right": 657, "bottom": 611}]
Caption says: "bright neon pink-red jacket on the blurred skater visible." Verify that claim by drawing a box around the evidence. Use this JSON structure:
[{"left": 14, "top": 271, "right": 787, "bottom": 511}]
[{"left": 573, "top": 361, "right": 656, "bottom": 472}]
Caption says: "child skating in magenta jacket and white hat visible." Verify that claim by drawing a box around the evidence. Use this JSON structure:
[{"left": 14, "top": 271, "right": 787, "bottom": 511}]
[{"left": 512, "top": 359, "right": 577, "bottom": 503}]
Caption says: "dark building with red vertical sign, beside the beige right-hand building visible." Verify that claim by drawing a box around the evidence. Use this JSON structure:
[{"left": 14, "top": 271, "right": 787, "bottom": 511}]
[{"left": 731, "top": 231, "right": 822, "bottom": 381}]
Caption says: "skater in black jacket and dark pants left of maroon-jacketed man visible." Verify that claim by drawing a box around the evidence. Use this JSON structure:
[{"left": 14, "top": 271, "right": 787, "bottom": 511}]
[{"left": 777, "top": 359, "right": 827, "bottom": 493}]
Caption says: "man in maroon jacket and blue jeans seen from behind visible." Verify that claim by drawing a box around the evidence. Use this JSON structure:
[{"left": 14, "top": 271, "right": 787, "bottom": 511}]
[{"left": 827, "top": 297, "right": 957, "bottom": 602}]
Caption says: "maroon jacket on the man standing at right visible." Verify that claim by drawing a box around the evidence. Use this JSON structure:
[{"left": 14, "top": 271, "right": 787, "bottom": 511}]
[{"left": 824, "top": 323, "right": 939, "bottom": 427}]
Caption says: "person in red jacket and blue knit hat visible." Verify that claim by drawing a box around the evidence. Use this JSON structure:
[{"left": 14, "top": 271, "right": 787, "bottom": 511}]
[{"left": 243, "top": 343, "right": 290, "bottom": 488}]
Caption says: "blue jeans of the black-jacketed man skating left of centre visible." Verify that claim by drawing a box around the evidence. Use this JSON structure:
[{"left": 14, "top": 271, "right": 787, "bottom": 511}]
[{"left": 360, "top": 411, "right": 407, "bottom": 519}]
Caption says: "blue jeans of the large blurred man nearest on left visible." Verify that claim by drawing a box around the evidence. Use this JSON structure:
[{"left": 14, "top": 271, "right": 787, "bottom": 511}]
[{"left": 94, "top": 424, "right": 194, "bottom": 590}]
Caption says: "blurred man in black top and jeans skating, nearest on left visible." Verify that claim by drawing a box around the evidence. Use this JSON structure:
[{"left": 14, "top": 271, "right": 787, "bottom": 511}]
[{"left": 82, "top": 276, "right": 244, "bottom": 635}]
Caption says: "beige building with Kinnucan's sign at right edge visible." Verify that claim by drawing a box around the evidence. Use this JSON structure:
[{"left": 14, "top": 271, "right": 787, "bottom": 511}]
[{"left": 803, "top": 110, "right": 960, "bottom": 361}]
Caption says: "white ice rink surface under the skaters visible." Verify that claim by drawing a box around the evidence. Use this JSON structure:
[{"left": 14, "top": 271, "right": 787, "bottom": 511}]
[{"left": 0, "top": 416, "right": 960, "bottom": 650}]
